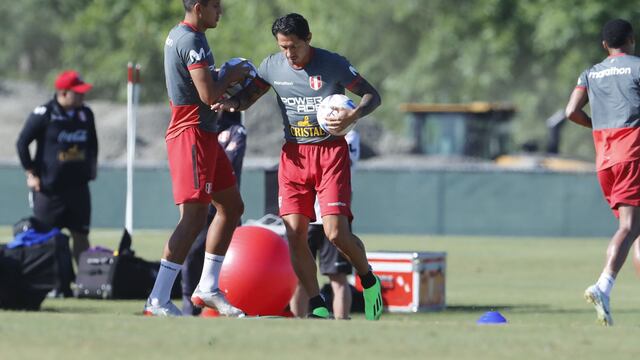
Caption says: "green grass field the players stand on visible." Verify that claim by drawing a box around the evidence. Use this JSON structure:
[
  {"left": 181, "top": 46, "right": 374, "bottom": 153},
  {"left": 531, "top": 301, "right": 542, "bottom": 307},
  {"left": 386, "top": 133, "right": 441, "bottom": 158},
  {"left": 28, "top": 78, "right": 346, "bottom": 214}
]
[{"left": 0, "top": 228, "right": 640, "bottom": 360}]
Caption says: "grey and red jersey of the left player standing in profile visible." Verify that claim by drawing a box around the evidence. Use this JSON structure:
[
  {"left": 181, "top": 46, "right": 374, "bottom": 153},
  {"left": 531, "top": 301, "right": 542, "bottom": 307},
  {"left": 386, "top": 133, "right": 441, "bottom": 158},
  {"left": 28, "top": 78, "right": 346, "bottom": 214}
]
[{"left": 164, "top": 22, "right": 217, "bottom": 139}]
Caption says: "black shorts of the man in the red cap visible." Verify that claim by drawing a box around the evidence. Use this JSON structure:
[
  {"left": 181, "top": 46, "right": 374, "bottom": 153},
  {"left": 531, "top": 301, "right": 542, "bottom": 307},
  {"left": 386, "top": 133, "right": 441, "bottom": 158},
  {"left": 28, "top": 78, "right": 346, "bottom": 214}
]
[{"left": 32, "top": 184, "right": 91, "bottom": 234}]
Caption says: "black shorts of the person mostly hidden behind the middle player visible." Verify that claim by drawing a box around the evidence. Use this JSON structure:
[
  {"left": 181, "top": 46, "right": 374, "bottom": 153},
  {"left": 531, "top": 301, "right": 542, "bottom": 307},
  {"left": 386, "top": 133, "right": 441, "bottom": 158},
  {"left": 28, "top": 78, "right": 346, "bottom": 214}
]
[{"left": 308, "top": 224, "right": 352, "bottom": 275}]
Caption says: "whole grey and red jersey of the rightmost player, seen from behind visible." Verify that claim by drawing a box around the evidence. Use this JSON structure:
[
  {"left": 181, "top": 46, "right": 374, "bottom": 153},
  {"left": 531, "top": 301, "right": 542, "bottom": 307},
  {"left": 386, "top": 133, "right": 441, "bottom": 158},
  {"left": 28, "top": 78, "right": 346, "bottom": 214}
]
[{"left": 576, "top": 54, "right": 640, "bottom": 170}]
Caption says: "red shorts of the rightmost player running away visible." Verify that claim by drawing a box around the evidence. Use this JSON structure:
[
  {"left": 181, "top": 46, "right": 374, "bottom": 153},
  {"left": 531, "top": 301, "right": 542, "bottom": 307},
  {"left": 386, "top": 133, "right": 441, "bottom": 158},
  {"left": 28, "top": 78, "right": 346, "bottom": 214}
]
[{"left": 598, "top": 159, "right": 640, "bottom": 217}]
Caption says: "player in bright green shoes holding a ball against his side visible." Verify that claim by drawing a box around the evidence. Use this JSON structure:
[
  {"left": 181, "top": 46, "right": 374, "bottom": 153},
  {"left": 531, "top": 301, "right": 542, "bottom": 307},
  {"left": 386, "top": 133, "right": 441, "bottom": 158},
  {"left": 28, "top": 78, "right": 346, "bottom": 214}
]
[{"left": 214, "top": 14, "right": 383, "bottom": 320}]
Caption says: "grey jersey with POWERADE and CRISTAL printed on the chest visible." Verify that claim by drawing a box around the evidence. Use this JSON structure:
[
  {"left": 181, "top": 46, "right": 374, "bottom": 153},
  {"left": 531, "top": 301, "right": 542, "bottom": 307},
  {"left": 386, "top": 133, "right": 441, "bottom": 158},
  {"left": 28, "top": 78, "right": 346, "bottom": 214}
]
[{"left": 258, "top": 48, "right": 360, "bottom": 144}]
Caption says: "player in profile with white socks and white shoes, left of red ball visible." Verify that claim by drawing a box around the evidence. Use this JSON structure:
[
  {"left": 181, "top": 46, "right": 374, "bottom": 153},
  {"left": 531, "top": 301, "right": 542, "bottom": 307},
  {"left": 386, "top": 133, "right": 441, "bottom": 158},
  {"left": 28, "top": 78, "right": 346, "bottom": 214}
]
[{"left": 144, "top": 0, "right": 249, "bottom": 317}]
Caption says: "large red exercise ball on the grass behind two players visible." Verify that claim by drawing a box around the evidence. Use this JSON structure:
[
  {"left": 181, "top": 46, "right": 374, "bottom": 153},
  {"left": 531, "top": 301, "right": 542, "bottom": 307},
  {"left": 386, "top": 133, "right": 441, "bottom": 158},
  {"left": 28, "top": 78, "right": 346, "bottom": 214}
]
[{"left": 220, "top": 226, "right": 298, "bottom": 316}]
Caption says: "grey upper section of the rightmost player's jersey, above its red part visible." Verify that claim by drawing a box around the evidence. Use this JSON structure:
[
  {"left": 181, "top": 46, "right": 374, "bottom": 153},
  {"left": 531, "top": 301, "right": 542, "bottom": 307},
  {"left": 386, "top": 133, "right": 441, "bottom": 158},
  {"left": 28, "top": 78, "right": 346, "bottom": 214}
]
[{"left": 577, "top": 54, "right": 640, "bottom": 130}]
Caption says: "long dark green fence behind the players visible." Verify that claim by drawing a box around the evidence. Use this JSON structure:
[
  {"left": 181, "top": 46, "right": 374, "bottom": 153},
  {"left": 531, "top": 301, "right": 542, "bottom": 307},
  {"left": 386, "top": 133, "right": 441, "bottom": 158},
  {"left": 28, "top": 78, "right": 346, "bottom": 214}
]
[{"left": 0, "top": 166, "right": 616, "bottom": 236}]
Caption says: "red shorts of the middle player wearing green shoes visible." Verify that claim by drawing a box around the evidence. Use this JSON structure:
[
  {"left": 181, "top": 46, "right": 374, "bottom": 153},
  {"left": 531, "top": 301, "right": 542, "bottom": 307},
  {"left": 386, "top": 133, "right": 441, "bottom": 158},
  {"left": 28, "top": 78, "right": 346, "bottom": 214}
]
[{"left": 278, "top": 138, "right": 353, "bottom": 221}]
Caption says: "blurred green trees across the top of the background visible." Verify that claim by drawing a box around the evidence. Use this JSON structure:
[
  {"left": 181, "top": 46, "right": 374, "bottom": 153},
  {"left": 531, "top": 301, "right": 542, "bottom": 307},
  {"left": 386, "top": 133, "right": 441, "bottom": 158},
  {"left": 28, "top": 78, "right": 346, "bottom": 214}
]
[{"left": 0, "top": 0, "right": 640, "bottom": 158}]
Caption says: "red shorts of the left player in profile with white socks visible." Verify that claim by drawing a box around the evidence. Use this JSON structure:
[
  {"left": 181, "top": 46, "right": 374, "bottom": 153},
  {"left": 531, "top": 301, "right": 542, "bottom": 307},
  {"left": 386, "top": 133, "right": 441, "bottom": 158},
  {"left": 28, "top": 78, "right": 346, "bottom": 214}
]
[{"left": 167, "top": 127, "right": 236, "bottom": 204}]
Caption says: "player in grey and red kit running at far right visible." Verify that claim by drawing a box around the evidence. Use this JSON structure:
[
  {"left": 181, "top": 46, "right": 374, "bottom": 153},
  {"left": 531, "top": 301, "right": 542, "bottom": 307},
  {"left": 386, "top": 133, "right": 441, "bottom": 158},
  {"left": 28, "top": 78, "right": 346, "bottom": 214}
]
[{"left": 566, "top": 19, "right": 640, "bottom": 326}]
